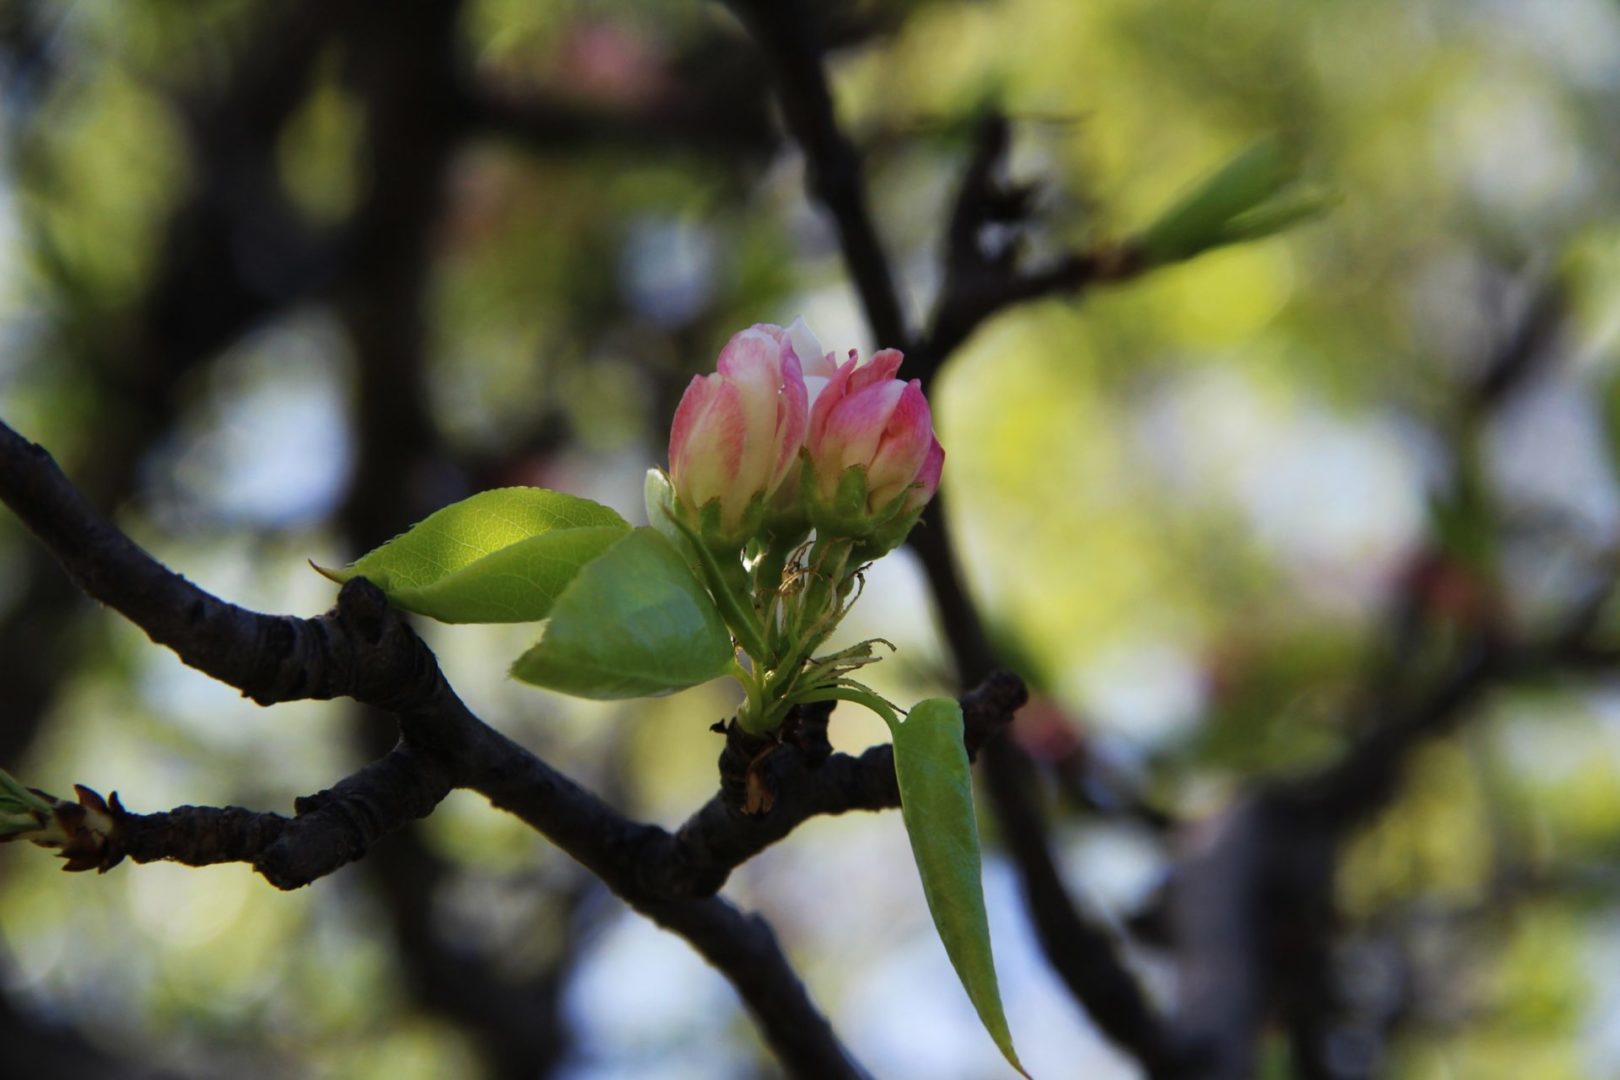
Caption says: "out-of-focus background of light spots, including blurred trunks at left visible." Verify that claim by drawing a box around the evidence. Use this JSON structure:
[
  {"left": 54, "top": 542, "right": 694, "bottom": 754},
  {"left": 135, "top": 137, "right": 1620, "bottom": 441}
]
[{"left": 0, "top": 0, "right": 1620, "bottom": 1080}]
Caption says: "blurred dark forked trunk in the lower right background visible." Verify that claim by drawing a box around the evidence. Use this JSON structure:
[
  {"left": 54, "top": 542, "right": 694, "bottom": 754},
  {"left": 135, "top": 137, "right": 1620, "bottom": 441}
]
[{"left": 1171, "top": 285, "right": 1594, "bottom": 1080}]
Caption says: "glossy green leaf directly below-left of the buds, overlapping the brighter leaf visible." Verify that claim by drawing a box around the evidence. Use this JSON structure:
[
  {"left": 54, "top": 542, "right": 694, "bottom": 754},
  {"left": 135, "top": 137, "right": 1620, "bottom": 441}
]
[{"left": 512, "top": 528, "right": 732, "bottom": 699}]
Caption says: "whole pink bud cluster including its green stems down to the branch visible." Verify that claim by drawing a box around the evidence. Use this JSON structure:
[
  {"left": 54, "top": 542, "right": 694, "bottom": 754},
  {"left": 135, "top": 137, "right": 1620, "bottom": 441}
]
[{"left": 648, "top": 321, "right": 944, "bottom": 732}]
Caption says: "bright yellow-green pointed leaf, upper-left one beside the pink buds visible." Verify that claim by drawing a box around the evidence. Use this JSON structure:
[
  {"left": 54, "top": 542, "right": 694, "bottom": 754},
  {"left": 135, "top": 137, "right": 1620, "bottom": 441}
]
[{"left": 316, "top": 487, "right": 630, "bottom": 622}]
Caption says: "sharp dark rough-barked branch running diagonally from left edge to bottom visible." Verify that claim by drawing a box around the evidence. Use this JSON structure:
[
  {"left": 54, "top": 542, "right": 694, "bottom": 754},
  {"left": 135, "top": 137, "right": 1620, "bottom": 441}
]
[{"left": 0, "top": 411, "right": 1022, "bottom": 1077}]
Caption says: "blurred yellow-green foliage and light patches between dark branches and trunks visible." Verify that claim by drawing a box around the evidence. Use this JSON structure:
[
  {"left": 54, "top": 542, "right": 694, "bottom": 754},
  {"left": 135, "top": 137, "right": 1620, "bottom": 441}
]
[{"left": 0, "top": 0, "right": 1620, "bottom": 1077}]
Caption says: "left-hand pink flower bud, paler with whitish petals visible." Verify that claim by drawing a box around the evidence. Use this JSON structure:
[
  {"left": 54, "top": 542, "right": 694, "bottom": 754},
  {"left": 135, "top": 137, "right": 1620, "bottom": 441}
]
[{"left": 669, "top": 324, "right": 808, "bottom": 547}]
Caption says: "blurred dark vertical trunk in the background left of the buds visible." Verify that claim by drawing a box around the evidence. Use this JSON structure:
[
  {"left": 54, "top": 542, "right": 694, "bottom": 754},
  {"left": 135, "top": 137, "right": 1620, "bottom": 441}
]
[{"left": 325, "top": 0, "right": 592, "bottom": 1080}]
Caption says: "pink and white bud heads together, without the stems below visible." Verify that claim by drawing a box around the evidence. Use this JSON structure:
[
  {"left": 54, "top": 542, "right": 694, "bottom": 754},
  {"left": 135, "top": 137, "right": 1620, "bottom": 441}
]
[{"left": 669, "top": 321, "right": 944, "bottom": 554}]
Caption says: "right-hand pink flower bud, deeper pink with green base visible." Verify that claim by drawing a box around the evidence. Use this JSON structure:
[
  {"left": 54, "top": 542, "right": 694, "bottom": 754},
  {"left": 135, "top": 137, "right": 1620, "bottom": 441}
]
[{"left": 805, "top": 348, "right": 944, "bottom": 542}]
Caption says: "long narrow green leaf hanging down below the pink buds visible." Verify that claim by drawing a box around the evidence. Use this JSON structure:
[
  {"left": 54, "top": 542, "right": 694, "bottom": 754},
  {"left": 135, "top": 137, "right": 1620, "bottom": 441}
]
[{"left": 878, "top": 698, "right": 1029, "bottom": 1077}]
